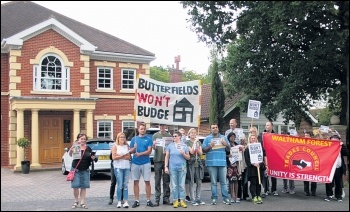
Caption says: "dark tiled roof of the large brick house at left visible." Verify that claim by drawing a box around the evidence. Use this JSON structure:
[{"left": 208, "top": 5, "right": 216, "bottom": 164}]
[{"left": 1, "top": 1, "right": 155, "bottom": 57}]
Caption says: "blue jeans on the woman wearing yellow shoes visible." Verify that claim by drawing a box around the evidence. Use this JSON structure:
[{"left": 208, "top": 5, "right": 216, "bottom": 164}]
[{"left": 169, "top": 169, "right": 186, "bottom": 201}]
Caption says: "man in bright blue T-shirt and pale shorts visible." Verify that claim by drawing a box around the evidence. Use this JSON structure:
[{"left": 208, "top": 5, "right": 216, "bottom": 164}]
[{"left": 130, "top": 123, "right": 154, "bottom": 208}]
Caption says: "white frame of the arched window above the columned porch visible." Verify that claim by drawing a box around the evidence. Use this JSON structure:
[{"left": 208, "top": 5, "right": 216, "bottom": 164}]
[{"left": 33, "top": 54, "right": 70, "bottom": 92}]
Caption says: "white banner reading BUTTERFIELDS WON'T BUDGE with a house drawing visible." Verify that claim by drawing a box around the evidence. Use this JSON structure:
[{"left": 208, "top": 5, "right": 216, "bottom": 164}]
[{"left": 134, "top": 74, "right": 202, "bottom": 127}]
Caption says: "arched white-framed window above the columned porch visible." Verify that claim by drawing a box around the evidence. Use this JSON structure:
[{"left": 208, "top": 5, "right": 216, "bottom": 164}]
[{"left": 33, "top": 55, "right": 70, "bottom": 91}]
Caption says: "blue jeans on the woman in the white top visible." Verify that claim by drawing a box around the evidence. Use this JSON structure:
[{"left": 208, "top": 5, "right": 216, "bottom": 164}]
[{"left": 114, "top": 168, "right": 130, "bottom": 201}]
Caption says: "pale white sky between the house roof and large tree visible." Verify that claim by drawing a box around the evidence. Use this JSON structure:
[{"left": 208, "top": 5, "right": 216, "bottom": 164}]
[{"left": 1, "top": 1, "right": 210, "bottom": 74}]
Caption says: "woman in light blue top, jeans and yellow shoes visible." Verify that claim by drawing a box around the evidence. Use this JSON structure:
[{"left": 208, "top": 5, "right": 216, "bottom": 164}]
[{"left": 164, "top": 132, "right": 190, "bottom": 208}]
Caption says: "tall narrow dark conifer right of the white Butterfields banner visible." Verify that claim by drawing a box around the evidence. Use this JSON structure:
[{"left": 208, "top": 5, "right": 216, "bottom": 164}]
[{"left": 209, "top": 59, "right": 225, "bottom": 131}]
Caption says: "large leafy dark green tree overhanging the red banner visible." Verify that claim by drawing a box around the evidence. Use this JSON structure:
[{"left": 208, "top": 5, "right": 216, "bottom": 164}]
[{"left": 181, "top": 1, "right": 349, "bottom": 125}]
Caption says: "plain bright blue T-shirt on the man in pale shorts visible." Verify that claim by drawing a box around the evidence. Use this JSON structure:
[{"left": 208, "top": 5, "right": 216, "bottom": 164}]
[{"left": 130, "top": 136, "right": 153, "bottom": 165}]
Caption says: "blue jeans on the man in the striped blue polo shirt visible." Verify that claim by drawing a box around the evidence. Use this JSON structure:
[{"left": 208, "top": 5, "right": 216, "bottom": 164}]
[{"left": 207, "top": 166, "right": 228, "bottom": 200}]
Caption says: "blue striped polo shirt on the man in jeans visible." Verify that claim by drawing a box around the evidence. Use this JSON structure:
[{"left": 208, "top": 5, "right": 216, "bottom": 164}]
[{"left": 203, "top": 134, "right": 230, "bottom": 166}]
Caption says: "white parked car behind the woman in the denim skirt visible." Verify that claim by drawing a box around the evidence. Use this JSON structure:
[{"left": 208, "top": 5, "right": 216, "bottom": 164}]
[{"left": 62, "top": 138, "right": 114, "bottom": 177}]
